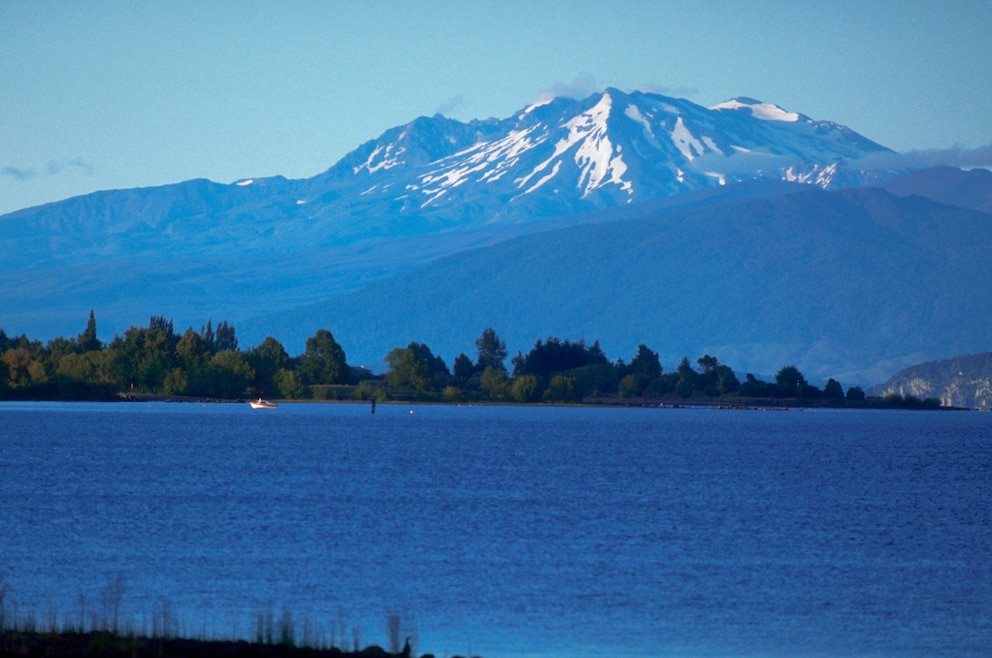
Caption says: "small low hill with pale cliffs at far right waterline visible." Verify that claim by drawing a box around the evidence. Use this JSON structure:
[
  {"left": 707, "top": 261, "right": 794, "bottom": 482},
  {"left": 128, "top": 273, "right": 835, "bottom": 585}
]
[{"left": 874, "top": 352, "right": 992, "bottom": 411}]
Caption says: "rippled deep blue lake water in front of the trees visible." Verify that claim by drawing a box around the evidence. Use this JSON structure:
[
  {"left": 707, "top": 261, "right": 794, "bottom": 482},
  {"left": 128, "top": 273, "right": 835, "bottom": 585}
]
[{"left": 0, "top": 403, "right": 992, "bottom": 658}]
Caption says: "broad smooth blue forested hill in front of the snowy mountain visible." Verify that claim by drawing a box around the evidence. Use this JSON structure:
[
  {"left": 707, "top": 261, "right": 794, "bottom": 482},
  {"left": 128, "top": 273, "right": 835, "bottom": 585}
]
[{"left": 249, "top": 187, "right": 992, "bottom": 385}]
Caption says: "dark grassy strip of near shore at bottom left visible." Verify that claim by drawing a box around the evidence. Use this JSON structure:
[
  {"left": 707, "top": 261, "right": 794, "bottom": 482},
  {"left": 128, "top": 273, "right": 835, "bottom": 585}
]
[{"left": 0, "top": 630, "right": 460, "bottom": 658}]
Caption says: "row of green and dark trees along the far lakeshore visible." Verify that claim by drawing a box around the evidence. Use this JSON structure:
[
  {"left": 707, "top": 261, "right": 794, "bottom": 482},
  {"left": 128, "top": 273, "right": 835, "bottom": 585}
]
[{"left": 0, "top": 311, "right": 940, "bottom": 408}]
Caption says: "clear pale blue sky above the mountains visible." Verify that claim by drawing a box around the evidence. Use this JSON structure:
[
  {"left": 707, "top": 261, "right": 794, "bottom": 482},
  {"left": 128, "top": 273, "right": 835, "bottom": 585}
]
[{"left": 0, "top": 0, "right": 992, "bottom": 213}]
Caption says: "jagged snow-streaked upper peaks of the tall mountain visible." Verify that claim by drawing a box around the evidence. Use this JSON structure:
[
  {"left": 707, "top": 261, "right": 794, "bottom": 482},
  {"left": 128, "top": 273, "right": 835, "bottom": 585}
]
[{"left": 294, "top": 89, "right": 887, "bottom": 231}]
